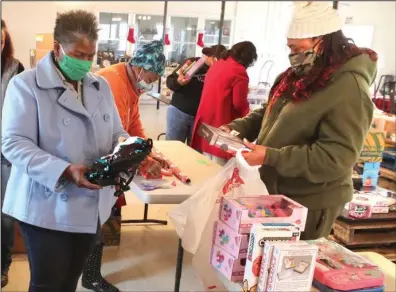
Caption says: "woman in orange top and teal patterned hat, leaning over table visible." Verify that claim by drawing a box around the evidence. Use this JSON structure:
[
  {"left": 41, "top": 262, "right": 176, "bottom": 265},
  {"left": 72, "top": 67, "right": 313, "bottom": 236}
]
[{"left": 82, "top": 41, "right": 165, "bottom": 292}]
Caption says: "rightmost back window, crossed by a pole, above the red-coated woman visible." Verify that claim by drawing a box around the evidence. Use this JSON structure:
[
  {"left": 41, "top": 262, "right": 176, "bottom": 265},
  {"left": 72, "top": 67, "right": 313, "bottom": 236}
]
[{"left": 204, "top": 19, "right": 231, "bottom": 48}]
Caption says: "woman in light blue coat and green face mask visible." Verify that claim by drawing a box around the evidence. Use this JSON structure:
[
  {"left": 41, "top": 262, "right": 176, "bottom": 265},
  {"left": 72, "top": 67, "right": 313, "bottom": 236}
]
[{"left": 2, "top": 10, "right": 128, "bottom": 292}]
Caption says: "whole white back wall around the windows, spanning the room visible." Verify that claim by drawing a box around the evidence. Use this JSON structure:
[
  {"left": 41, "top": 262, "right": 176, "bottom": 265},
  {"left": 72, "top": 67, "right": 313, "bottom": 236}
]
[{"left": 1, "top": 1, "right": 396, "bottom": 84}]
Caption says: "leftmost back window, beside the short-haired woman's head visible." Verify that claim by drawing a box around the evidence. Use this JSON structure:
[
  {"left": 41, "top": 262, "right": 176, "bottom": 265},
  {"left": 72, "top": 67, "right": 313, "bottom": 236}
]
[{"left": 98, "top": 12, "right": 129, "bottom": 61}]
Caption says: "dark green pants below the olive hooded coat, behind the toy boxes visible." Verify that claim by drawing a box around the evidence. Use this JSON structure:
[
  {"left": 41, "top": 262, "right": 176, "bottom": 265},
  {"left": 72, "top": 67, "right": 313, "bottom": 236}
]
[{"left": 301, "top": 204, "right": 345, "bottom": 240}]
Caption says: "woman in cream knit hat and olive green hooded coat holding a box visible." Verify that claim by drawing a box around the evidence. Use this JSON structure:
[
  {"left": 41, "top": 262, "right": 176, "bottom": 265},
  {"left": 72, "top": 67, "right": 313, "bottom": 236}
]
[{"left": 222, "top": 1, "right": 377, "bottom": 239}]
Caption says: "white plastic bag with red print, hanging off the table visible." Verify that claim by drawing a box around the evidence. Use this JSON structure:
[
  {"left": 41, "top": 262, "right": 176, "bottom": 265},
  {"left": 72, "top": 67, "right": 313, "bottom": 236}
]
[{"left": 169, "top": 149, "right": 268, "bottom": 254}]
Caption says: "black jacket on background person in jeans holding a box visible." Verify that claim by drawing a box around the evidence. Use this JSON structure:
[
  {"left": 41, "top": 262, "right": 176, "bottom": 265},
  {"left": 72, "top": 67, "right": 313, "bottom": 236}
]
[{"left": 166, "top": 58, "right": 209, "bottom": 117}]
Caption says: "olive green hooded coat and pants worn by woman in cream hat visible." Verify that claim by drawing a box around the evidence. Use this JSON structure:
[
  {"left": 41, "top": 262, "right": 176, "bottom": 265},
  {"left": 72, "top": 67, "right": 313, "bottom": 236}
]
[{"left": 228, "top": 54, "right": 377, "bottom": 239}]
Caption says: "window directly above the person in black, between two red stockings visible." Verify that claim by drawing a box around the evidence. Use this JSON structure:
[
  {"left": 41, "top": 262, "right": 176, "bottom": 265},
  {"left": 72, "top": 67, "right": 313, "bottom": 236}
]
[{"left": 168, "top": 16, "right": 198, "bottom": 63}]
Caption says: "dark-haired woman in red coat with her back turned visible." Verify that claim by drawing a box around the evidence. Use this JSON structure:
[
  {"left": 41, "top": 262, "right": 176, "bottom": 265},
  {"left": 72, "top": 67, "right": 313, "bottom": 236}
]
[{"left": 191, "top": 42, "right": 257, "bottom": 165}]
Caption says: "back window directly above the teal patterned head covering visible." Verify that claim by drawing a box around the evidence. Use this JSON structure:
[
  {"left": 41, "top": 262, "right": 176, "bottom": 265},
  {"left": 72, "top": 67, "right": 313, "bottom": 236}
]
[{"left": 136, "top": 14, "right": 164, "bottom": 48}]
